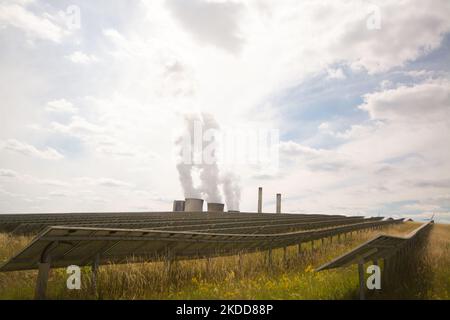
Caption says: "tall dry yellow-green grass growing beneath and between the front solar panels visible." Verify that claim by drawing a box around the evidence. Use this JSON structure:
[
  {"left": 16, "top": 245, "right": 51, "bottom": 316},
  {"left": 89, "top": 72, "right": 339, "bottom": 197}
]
[{"left": 0, "top": 223, "right": 450, "bottom": 299}]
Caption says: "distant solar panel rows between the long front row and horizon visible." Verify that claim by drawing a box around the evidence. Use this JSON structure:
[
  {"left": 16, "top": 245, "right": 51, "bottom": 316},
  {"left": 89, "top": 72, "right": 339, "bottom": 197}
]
[{"left": 0, "top": 212, "right": 381, "bottom": 234}]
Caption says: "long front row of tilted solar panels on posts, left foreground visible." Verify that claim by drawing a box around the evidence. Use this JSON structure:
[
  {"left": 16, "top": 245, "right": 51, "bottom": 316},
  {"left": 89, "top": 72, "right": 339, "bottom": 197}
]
[{"left": 0, "top": 220, "right": 401, "bottom": 271}]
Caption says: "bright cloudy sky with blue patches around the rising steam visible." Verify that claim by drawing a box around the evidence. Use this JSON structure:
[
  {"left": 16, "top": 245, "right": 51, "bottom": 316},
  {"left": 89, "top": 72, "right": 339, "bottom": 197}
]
[{"left": 0, "top": 0, "right": 450, "bottom": 222}]
